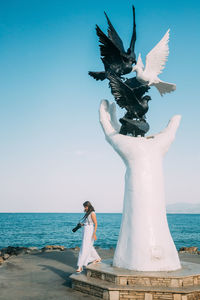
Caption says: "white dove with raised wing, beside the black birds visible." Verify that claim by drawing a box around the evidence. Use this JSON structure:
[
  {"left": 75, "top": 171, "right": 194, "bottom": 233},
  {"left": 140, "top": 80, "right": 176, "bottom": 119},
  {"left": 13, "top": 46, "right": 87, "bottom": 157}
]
[{"left": 132, "top": 29, "right": 176, "bottom": 96}]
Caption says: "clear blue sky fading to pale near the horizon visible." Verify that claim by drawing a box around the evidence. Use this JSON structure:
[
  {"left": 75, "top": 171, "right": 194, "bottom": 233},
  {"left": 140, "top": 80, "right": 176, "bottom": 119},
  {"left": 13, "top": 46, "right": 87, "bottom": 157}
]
[{"left": 0, "top": 0, "right": 200, "bottom": 212}]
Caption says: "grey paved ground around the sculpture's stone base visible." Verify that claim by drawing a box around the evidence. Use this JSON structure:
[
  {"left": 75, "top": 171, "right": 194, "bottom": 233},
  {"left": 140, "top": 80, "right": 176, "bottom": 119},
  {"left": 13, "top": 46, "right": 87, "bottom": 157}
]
[{"left": 0, "top": 249, "right": 200, "bottom": 300}]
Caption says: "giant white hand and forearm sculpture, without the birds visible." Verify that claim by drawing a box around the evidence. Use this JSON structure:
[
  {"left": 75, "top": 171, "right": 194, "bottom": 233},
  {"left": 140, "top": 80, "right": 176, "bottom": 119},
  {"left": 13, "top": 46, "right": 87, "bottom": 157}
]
[{"left": 99, "top": 100, "right": 181, "bottom": 271}]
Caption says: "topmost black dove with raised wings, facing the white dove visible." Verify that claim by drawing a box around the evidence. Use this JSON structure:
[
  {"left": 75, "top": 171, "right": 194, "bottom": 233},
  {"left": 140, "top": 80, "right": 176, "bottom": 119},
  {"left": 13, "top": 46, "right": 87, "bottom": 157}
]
[{"left": 88, "top": 6, "right": 136, "bottom": 80}]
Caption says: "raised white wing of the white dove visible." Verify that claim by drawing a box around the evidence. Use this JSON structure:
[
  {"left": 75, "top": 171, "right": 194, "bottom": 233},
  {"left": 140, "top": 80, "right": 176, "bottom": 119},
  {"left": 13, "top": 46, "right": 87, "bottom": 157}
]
[{"left": 144, "top": 29, "right": 169, "bottom": 76}]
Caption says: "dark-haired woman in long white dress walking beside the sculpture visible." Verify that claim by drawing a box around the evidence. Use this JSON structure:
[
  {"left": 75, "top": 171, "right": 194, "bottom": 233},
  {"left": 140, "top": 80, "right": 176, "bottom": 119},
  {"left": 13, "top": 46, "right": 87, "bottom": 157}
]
[{"left": 76, "top": 201, "right": 101, "bottom": 273}]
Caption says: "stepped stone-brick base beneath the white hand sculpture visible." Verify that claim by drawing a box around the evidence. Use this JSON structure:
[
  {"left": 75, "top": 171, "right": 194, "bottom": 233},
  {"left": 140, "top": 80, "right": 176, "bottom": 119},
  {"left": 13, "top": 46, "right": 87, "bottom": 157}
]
[{"left": 70, "top": 260, "right": 200, "bottom": 300}]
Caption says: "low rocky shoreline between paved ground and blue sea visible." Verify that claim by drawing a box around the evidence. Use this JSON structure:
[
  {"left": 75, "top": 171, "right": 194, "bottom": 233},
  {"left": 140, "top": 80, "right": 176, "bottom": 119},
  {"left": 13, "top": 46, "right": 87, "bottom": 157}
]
[{"left": 0, "top": 245, "right": 200, "bottom": 265}]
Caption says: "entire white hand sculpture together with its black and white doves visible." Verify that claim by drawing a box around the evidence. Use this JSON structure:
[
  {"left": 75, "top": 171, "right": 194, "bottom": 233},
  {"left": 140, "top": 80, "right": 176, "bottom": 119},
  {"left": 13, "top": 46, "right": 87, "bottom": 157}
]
[{"left": 89, "top": 7, "right": 181, "bottom": 271}]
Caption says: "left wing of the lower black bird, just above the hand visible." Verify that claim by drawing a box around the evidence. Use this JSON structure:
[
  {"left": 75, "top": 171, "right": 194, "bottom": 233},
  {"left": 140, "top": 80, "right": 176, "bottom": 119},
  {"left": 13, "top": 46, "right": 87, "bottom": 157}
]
[{"left": 107, "top": 73, "right": 138, "bottom": 108}]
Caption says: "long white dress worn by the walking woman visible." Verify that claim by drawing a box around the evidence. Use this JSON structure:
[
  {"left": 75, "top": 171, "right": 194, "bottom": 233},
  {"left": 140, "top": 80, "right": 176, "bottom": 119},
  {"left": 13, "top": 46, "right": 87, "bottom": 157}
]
[{"left": 77, "top": 211, "right": 100, "bottom": 268}]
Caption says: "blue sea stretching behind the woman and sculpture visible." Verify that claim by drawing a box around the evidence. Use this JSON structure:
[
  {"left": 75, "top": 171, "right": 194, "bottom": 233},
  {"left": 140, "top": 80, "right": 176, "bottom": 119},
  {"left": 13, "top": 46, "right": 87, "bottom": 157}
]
[{"left": 0, "top": 213, "right": 200, "bottom": 249}]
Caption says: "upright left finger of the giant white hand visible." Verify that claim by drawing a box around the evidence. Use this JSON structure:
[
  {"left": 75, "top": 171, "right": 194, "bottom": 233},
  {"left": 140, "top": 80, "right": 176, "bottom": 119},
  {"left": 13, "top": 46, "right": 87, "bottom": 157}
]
[{"left": 99, "top": 100, "right": 117, "bottom": 136}]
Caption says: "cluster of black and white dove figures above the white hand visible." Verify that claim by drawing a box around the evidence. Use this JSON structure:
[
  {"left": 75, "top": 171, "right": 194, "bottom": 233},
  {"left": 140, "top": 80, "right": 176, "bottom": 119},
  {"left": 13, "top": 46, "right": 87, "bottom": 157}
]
[{"left": 88, "top": 6, "right": 176, "bottom": 137}]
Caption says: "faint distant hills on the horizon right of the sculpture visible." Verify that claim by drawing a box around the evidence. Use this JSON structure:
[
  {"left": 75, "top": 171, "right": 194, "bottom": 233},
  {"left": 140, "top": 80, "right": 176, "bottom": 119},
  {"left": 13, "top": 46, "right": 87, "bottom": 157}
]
[{"left": 167, "top": 203, "right": 200, "bottom": 214}]
